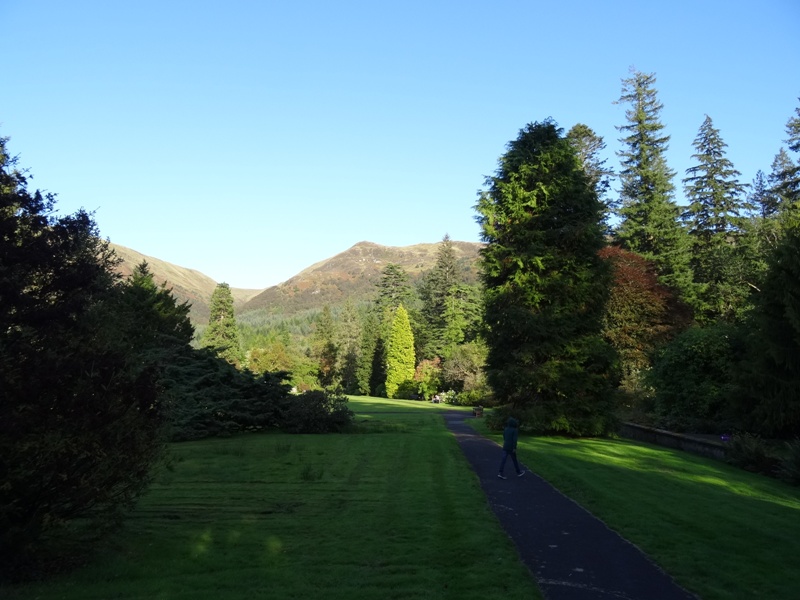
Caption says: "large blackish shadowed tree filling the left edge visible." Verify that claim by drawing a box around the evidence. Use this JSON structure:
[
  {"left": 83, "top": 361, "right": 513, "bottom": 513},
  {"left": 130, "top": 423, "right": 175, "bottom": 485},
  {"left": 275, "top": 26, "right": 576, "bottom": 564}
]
[{"left": 0, "top": 138, "right": 173, "bottom": 576}]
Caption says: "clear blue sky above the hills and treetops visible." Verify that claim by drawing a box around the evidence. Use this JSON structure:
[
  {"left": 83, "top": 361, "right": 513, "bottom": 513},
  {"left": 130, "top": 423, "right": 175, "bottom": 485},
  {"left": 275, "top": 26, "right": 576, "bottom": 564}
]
[{"left": 0, "top": 0, "right": 800, "bottom": 288}]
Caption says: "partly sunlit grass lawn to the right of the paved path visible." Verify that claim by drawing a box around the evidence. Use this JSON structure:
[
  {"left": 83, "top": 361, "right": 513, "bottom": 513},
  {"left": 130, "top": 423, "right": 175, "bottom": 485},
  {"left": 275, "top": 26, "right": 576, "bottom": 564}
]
[{"left": 473, "top": 420, "right": 800, "bottom": 600}]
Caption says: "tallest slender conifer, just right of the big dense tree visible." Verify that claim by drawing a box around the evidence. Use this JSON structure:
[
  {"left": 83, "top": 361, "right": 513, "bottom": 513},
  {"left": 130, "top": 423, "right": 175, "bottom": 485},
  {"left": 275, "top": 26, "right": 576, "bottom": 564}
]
[{"left": 616, "top": 71, "right": 691, "bottom": 293}]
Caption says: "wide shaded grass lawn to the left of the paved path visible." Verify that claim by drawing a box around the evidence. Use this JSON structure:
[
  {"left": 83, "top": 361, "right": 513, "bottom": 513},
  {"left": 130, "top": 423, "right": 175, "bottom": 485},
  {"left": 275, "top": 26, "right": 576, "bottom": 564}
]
[{"left": 0, "top": 398, "right": 541, "bottom": 600}]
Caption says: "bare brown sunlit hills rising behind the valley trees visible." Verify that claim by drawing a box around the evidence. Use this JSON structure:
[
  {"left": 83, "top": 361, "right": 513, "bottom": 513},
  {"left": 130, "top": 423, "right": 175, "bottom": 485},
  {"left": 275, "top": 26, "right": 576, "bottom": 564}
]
[{"left": 111, "top": 241, "right": 483, "bottom": 325}]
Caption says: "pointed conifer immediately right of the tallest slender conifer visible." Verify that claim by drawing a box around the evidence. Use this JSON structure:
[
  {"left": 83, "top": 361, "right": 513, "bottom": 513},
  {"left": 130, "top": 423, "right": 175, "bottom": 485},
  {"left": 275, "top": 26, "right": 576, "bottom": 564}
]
[{"left": 683, "top": 116, "right": 750, "bottom": 322}]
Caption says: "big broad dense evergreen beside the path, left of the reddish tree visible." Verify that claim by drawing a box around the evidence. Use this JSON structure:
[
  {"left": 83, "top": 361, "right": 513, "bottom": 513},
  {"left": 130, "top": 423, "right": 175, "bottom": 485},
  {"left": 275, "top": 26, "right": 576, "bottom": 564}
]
[{"left": 476, "top": 120, "right": 617, "bottom": 434}]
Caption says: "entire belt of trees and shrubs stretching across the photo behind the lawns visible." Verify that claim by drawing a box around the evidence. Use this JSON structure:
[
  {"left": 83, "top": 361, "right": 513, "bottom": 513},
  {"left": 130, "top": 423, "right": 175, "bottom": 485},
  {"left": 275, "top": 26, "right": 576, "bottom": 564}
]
[{"left": 0, "top": 72, "right": 800, "bottom": 577}]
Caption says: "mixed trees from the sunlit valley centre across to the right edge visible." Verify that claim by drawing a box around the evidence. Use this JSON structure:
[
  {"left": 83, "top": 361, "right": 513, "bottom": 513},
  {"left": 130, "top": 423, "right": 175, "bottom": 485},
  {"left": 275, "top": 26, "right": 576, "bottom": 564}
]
[{"left": 227, "top": 72, "right": 800, "bottom": 439}]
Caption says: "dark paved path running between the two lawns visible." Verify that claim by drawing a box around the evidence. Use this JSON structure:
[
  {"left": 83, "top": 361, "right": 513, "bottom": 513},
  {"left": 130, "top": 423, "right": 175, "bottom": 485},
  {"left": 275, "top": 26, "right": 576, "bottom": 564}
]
[{"left": 445, "top": 412, "right": 696, "bottom": 600}]
